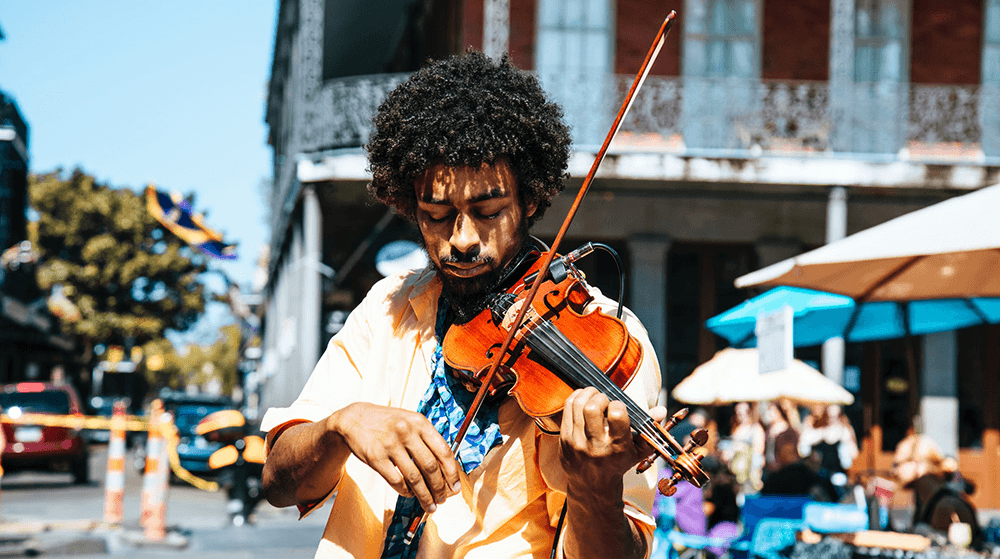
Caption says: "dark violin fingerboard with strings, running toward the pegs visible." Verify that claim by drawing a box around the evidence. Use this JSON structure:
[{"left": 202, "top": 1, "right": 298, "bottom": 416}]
[{"left": 527, "top": 322, "right": 666, "bottom": 444}]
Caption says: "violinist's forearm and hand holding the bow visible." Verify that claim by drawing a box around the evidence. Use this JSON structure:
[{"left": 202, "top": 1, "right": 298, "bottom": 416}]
[{"left": 263, "top": 402, "right": 460, "bottom": 512}]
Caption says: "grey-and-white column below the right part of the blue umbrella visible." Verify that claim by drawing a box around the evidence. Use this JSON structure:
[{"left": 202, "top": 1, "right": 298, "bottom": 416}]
[{"left": 919, "top": 332, "right": 958, "bottom": 457}]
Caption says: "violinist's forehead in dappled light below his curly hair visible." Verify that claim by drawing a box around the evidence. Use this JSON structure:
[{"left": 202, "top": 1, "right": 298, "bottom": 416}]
[{"left": 415, "top": 160, "right": 517, "bottom": 204}]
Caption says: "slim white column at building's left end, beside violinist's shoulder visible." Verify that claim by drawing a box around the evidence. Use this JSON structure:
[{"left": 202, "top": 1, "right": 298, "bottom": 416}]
[{"left": 298, "top": 186, "right": 323, "bottom": 377}]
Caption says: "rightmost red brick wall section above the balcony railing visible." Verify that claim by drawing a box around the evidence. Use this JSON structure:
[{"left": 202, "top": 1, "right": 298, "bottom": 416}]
[{"left": 910, "top": 0, "right": 983, "bottom": 85}]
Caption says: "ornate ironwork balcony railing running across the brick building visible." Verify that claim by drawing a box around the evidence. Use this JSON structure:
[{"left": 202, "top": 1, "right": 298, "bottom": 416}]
[{"left": 303, "top": 74, "right": 1000, "bottom": 165}]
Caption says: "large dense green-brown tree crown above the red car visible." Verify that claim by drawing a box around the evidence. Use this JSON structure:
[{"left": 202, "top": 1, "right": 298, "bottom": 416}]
[{"left": 29, "top": 169, "right": 206, "bottom": 346}]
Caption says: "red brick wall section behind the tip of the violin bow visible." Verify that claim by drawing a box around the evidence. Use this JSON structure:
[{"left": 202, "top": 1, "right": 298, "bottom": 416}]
[{"left": 615, "top": 0, "right": 684, "bottom": 76}]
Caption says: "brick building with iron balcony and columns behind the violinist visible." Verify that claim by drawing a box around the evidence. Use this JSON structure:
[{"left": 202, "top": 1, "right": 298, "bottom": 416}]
[{"left": 261, "top": 0, "right": 1000, "bottom": 508}]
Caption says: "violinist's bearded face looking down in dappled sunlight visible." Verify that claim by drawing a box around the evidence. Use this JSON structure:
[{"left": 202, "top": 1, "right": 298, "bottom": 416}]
[{"left": 415, "top": 160, "right": 536, "bottom": 298}]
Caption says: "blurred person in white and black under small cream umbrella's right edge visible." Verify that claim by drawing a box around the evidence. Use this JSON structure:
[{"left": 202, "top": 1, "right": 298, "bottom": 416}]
[{"left": 799, "top": 404, "right": 858, "bottom": 486}]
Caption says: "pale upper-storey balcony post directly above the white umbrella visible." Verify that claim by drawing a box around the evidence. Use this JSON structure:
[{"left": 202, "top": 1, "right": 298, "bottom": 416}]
[{"left": 830, "top": 0, "right": 854, "bottom": 152}]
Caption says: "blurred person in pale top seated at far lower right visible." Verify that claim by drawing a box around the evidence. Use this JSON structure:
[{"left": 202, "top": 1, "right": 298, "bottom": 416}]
[{"left": 893, "top": 434, "right": 983, "bottom": 549}]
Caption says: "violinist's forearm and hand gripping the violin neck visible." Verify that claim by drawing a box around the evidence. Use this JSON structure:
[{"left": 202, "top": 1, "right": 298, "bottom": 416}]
[{"left": 560, "top": 388, "right": 666, "bottom": 559}]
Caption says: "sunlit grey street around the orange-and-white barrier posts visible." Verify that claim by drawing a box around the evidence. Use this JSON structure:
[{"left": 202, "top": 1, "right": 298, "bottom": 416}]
[{"left": 0, "top": 445, "right": 329, "bottom": 559}]
